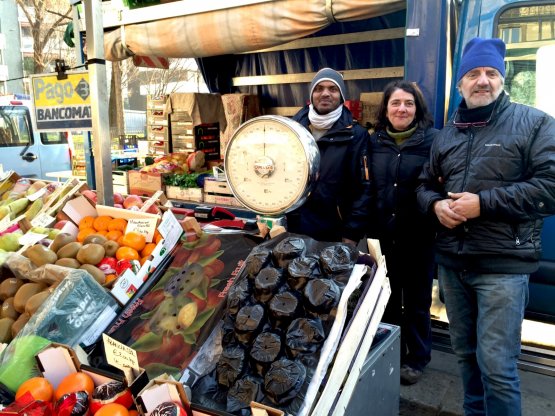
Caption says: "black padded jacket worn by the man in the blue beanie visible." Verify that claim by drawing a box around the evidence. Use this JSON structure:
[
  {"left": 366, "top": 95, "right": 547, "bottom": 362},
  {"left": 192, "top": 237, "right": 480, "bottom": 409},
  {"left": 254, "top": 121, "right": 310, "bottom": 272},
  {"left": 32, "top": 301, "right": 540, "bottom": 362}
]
[{"left": 418, "top": 93, "right": 555, "bottom": 273}]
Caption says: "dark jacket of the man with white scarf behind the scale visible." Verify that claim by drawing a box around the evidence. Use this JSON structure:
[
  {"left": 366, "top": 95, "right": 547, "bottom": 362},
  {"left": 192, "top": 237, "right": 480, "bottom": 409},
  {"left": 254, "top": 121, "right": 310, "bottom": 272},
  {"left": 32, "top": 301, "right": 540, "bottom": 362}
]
[{"left": 287, "top": 106, "right": 370, "bottom": 241}]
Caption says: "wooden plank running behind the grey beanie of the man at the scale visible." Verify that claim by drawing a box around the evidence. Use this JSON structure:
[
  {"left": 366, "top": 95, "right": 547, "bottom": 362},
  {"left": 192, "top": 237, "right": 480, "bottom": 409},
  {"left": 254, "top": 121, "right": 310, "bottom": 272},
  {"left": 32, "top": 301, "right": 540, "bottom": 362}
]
[{"left": 232, "top": 66, "right": 405, "bottom": 87}]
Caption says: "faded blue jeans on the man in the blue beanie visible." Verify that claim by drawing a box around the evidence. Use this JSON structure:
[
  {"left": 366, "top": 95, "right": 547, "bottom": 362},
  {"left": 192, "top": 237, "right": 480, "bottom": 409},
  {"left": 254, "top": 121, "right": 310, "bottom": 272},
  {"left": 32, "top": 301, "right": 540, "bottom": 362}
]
[{"left": 438, "top": 266, "right": 529, "bottom": 416}]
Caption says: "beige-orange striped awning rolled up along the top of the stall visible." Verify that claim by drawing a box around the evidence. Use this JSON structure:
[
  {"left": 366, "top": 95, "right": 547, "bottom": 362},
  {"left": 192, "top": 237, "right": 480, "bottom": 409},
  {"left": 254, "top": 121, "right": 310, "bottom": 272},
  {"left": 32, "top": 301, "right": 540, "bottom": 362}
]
[{"left": 104, "top": 0, "right": 406, "bottom": 61}]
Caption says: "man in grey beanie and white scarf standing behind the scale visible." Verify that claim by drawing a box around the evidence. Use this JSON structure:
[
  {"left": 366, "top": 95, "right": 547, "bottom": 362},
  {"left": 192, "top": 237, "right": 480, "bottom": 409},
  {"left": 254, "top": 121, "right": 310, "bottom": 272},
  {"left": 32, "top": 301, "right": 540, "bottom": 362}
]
[{"left": 287, "top": 68, "right": 370, "bottom": 244}]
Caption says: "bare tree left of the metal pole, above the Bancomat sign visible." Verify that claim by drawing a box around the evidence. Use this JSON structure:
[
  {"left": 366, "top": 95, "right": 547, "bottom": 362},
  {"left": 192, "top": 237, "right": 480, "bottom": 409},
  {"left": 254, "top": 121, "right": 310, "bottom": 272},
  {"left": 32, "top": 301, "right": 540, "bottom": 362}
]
[{"left": 15, "top": 0, "right": 74, "bottom": 74}]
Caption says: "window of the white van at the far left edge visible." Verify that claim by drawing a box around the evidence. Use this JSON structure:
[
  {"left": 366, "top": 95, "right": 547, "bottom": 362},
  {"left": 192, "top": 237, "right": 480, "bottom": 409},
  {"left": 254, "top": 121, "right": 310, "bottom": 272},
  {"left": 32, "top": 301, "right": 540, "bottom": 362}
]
[{"left": 0, "top": 106, "right": 33, "bottom": 147}]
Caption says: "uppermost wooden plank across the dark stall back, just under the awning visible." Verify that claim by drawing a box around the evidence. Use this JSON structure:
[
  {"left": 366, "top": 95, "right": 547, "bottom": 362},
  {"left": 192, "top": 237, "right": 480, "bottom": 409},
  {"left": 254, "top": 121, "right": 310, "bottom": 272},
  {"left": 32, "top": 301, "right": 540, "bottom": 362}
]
[{"left": 247, "top": 27, "right": 405, "bottom": 54}]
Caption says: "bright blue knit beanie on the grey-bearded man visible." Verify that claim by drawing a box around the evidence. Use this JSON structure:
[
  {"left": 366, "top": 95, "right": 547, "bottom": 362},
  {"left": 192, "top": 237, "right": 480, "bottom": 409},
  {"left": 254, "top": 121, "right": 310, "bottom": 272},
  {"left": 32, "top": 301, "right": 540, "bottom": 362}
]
[{"left": 457, "top": 38, "right": 505, "bottom": 82}]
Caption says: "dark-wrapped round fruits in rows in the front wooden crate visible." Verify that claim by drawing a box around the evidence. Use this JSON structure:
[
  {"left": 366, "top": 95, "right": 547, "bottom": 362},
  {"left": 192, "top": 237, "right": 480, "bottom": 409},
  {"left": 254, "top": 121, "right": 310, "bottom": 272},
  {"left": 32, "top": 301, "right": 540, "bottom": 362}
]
[{"left": 192, "top": 233, "right": 358, "bottom": 415}]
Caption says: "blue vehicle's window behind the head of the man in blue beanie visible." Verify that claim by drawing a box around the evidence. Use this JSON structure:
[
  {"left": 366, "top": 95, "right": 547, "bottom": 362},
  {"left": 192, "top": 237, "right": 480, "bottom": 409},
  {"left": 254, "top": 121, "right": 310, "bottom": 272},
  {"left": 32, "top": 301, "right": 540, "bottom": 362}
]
[{"left": 497, "top": 2, "right": 555, "bottom": 107}]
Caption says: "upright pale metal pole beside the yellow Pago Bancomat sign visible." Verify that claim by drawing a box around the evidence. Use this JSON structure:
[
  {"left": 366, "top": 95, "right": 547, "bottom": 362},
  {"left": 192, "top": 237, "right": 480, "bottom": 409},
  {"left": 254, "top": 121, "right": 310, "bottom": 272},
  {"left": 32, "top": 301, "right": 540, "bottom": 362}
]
[{"left": 84, "top": 0, "right": 114, "bottom": 206}]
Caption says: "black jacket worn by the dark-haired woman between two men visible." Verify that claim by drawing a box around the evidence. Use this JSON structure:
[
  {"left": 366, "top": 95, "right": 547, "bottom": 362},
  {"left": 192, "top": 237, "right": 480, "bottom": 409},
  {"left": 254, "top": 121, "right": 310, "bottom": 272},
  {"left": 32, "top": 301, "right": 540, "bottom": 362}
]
[{"left": 368, "top": 128, "right": 438, "bottom": 247}]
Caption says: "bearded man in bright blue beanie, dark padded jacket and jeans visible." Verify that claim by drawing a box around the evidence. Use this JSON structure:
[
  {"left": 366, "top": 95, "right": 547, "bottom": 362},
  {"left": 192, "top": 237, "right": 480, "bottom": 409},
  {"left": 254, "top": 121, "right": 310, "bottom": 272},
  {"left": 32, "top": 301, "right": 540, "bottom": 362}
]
[{"left": 418, "top": 38, "right": 555, "bottom": 416}]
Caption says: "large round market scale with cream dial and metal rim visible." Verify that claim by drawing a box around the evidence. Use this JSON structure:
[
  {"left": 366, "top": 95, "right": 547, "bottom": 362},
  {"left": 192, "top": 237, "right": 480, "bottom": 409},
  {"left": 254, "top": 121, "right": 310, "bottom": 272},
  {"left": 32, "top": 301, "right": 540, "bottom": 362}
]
[{"left": 224, "top": 116, "right": 320, "bottom": 215}]
